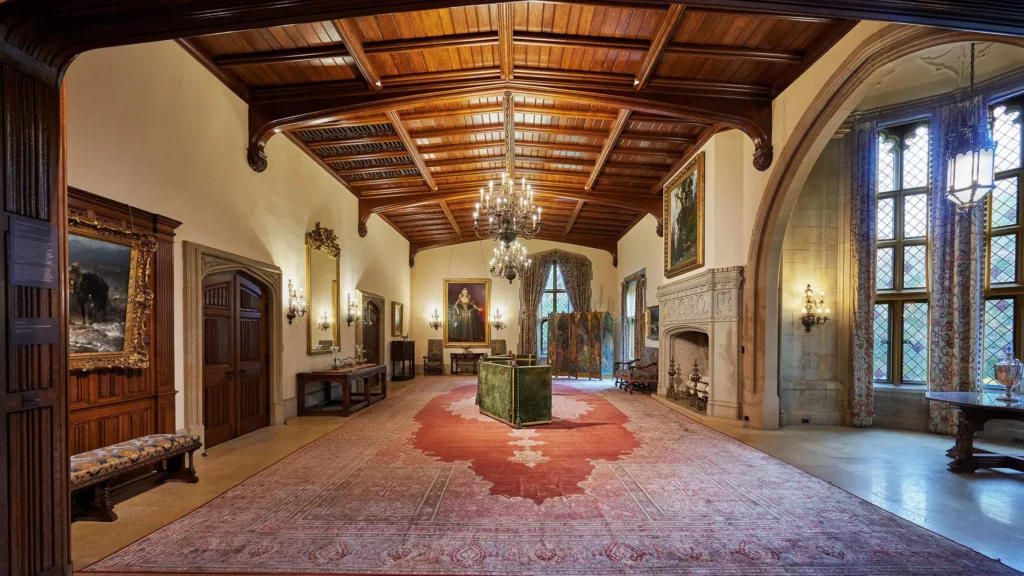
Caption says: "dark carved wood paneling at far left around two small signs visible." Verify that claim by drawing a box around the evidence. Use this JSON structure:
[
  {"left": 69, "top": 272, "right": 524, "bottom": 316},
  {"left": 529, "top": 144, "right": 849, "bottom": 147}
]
[{"left": 0, "top": 59, "right": 71, "bottom": 576}]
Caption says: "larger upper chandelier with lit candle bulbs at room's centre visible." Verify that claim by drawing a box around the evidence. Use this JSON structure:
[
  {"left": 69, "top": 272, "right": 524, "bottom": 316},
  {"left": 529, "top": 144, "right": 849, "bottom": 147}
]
[{"left": 473, "top": 170, "right": 541, "bottom": 244}]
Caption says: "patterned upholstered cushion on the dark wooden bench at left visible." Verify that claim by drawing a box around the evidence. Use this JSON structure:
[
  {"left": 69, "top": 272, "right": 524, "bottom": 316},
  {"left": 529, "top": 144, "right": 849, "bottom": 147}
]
[{"left": 71, "top": 434, "right": 200, "bottom": 489}]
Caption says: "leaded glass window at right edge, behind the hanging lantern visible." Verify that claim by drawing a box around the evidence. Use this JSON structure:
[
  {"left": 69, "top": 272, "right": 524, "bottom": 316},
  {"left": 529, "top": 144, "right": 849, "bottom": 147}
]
[{"left": 981, "top": 96, "right": 1024, "bottom": 385}]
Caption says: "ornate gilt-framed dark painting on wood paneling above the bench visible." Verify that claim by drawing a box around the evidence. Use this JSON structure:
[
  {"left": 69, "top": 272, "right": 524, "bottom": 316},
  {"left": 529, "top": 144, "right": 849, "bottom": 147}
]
[{"left": 68, "top": 213, "right": 157, "bottom": 370}]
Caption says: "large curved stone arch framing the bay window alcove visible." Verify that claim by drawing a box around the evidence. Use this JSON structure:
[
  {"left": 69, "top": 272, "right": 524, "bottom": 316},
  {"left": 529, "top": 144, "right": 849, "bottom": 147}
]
[{"left": 742, "top": 25, "right": 1024, "bottom": 428}]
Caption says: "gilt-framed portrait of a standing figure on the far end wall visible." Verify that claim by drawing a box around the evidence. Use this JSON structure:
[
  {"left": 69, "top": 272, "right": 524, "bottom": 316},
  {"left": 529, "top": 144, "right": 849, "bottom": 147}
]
[{"left": 443, "top": 278, "right": 490, "bottom": 347}]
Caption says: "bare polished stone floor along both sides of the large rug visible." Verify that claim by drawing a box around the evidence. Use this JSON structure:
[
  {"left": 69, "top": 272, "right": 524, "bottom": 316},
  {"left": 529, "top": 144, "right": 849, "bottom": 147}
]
[{"left": 72, "top": 377, "right": 1024, "bottom": 570}]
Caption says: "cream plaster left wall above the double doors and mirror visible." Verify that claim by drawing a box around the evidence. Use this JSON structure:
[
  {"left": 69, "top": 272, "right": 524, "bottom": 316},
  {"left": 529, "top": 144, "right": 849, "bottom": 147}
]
[{"left": 67, "top": 42, "right": 415, "bottom": 426}]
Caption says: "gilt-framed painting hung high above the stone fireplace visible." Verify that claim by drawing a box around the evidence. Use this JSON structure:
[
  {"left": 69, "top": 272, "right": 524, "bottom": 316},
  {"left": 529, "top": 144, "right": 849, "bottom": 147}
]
[{"left": 662, "top": 152, "right": 705, "bottom": 278}]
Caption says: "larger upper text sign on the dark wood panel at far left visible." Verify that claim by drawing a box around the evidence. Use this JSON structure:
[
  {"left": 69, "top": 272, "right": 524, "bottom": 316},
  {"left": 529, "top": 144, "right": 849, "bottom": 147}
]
[{"left": 7, "top": 214, "right": 59, "bottom": 290}]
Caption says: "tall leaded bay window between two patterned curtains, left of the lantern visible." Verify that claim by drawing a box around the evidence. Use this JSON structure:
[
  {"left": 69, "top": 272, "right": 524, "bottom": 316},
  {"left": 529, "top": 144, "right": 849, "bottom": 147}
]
[{"left": 873, "top": 122, "right": 931, "bottom": 384}]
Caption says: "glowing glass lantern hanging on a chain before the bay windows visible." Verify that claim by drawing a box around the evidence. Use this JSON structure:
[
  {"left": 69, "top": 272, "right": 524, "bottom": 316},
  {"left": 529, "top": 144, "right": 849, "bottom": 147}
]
[{"left": 946, "top": 42, "right": 995, "bottom": 209}]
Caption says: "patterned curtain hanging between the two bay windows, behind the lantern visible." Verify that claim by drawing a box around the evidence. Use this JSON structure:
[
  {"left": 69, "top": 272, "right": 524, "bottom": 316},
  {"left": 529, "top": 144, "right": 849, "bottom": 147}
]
[{"left": 928, "top": 97, "right": 988, "bottom": 435}]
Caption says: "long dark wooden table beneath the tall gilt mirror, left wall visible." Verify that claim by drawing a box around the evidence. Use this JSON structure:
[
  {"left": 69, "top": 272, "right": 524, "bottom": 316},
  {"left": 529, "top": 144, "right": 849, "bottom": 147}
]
[{"left": 295, "top": 364, "right": 387, "bottom": 416}]
